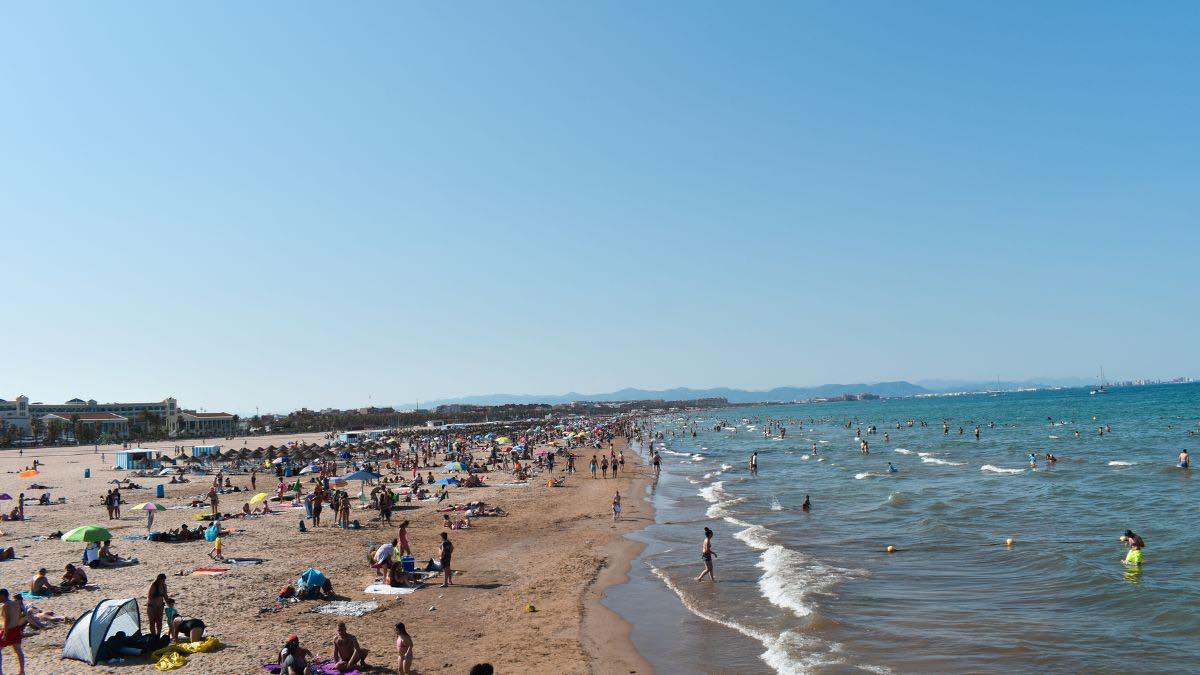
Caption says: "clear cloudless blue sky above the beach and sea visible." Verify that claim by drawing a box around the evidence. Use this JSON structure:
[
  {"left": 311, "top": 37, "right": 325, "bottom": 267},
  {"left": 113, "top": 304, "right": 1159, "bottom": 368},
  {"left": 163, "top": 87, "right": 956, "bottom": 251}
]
[{"left": 0, "top": 0, "right": 1200, "bottom": 413}]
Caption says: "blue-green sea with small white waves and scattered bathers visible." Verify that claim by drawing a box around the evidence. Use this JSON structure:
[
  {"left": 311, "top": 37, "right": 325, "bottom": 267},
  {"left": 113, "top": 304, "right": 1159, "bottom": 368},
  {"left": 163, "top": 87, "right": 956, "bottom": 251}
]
[{"left": 605, "top": 384, "right": 1200, "bottom": 674}]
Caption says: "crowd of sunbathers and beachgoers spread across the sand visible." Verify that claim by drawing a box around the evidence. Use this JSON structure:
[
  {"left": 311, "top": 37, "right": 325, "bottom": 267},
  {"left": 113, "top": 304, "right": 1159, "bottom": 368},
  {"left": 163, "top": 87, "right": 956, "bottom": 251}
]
[{"left": 0, "top": 419, "right": 648, "bottom": 675}]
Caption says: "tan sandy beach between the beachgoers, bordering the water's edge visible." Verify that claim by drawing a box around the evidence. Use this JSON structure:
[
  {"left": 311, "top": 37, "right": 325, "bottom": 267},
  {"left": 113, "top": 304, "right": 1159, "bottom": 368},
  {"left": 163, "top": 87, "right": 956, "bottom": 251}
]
[{"left": 0, "top": 435, "right": 653, "bottom": 674}]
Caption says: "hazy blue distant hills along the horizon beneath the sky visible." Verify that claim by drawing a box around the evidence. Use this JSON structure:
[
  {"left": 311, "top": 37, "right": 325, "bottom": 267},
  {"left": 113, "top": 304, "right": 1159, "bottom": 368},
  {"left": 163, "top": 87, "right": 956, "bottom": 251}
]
[{"left": 400, "top": 377, "right": 1094, "bottom": 408}]
